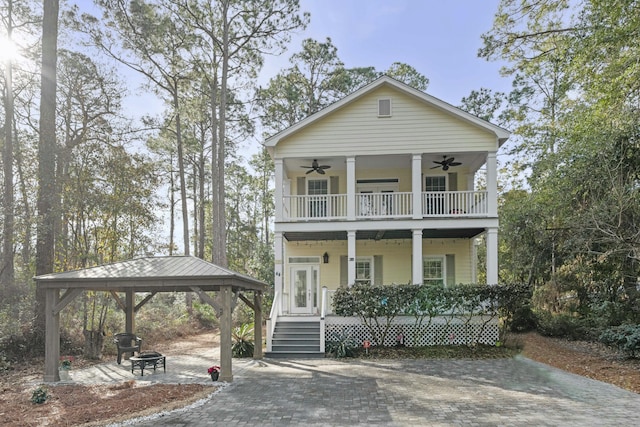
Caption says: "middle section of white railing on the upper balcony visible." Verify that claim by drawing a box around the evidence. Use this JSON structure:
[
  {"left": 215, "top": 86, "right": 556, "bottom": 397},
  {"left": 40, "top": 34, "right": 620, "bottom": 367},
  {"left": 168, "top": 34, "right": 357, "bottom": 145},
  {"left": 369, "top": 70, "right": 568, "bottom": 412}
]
[{"left": 356, "top": 193, "right": 413, "bottom": 218}]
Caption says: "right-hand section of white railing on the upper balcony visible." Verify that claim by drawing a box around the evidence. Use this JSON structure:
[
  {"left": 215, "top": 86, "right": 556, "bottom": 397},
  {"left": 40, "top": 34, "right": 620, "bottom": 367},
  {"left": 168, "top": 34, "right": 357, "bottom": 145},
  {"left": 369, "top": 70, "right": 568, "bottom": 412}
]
[{"left": 422, "top": 191, "right": 489, "bottom": 217}]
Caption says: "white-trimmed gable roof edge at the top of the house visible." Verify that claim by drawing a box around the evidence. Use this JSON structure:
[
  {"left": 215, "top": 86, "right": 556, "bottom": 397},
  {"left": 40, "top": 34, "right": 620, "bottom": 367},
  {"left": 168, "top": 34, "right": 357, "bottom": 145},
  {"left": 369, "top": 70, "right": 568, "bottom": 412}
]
[{"left": 265, "top": 76, "right": 511, "bottom": 154}]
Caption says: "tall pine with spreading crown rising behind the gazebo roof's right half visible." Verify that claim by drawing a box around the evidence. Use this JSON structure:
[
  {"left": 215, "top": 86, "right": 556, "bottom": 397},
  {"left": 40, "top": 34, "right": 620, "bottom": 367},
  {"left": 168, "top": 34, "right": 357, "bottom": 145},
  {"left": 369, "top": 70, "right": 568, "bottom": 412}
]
[{"left": 166, "top": 0, "right": 308, "bottom": 266}]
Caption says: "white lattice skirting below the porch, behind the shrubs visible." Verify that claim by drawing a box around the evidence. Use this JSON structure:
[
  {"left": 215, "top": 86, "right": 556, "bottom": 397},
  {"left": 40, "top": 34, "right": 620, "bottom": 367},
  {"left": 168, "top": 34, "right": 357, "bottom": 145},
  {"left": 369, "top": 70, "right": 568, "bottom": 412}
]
[{"left": 325, "top": 316, "right": 499, "bottom": 347}]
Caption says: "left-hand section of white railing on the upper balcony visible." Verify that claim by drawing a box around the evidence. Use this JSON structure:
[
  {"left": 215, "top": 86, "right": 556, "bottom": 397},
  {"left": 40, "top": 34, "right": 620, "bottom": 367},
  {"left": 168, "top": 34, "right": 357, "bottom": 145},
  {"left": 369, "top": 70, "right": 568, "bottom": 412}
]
[{"left": 283, "top": 194, "right": 347, "bottom": 220}]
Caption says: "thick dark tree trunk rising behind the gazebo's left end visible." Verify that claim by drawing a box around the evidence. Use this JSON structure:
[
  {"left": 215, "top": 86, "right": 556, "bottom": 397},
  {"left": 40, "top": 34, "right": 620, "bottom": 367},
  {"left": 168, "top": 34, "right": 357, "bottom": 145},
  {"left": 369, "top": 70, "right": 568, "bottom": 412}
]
[{"left": 33, "top": 0, "right": 59, "bottom": 334}]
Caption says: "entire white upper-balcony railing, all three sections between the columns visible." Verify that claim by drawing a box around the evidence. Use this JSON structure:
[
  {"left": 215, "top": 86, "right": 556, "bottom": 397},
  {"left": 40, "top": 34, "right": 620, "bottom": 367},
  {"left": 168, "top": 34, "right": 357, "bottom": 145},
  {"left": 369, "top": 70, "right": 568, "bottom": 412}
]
[{"left": 283, "top": 191, "right": 489, "bottom": 221}]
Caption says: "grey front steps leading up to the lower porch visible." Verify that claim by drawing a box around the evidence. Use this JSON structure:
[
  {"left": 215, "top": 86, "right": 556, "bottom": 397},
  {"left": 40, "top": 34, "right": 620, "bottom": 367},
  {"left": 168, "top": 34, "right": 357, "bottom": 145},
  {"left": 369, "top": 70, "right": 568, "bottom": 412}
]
[{"left": 265, "top": 321, "right": 324, "bottom": 359}]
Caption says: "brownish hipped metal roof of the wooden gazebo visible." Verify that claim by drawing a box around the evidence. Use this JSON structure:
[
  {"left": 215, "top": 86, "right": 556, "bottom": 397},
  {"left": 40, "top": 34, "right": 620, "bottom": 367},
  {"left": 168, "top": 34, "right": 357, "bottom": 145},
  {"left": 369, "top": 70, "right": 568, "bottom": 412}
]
[{"left": 35, "top": 256, "right": 267, "bottom": 291}]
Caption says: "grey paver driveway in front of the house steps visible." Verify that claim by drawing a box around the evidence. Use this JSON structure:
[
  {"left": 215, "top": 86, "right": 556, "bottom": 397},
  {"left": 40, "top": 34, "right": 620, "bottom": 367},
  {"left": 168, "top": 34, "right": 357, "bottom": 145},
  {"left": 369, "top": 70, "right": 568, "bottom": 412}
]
[{"left": 126, "top": 357, "right": 640, "bottom": 426}]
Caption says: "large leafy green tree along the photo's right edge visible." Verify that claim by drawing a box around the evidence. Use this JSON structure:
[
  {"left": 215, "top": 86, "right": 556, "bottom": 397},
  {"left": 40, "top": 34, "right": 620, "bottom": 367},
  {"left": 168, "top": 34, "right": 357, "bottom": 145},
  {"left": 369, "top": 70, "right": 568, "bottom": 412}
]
[{"left": 480, "top": 0, "right": 640, "bottom": 321}]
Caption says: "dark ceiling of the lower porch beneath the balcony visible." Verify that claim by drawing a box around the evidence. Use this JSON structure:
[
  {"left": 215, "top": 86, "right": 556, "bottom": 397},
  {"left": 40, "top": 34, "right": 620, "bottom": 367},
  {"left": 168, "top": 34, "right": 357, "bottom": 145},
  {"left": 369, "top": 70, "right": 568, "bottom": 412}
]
[{"left": 284, "top": 228, "right": 484, "bottom": 242}]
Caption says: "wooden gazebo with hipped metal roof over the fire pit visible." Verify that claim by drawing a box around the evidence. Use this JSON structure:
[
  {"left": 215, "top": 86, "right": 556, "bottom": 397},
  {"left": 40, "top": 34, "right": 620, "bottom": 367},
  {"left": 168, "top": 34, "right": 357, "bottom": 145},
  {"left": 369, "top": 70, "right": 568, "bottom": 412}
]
[{"left": 35, "top": 256, "right": 267, "bottom": 382}]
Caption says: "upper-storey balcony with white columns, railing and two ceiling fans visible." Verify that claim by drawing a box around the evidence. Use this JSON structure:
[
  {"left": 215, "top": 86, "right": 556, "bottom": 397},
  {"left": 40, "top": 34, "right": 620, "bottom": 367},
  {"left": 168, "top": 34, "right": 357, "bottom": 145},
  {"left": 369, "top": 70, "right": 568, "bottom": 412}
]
[{"left": 275, "top": 152, "right": 497, "bottom": 223}]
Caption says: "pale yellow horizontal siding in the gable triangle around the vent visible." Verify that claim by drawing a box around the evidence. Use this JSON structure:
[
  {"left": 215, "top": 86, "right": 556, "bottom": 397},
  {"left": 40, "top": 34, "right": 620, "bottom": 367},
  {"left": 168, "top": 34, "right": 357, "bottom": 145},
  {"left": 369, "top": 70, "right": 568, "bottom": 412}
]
[{"left": 275, "top": 86, "right": 497, "bottom": 158}]
